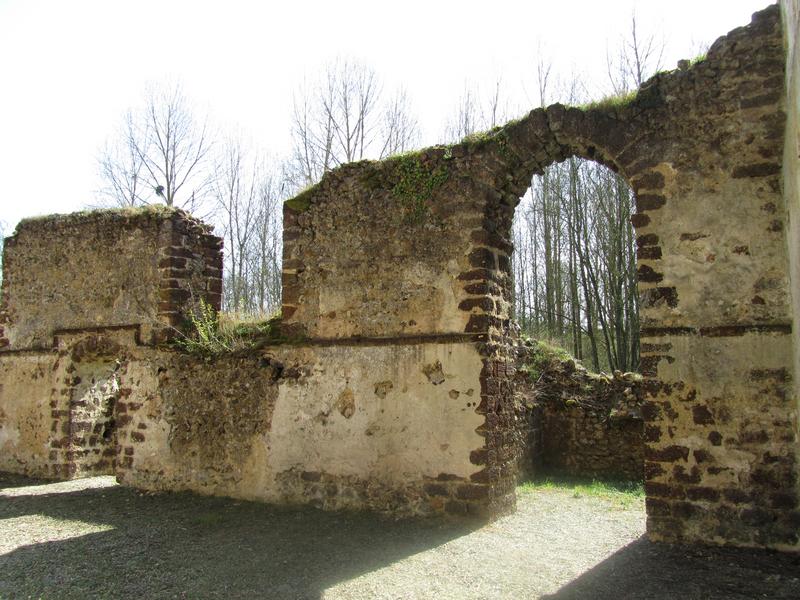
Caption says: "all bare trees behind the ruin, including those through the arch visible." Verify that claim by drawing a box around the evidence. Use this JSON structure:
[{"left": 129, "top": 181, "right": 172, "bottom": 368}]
[{"left": 98, "top": 12, "right": 676, "bottom": 370}]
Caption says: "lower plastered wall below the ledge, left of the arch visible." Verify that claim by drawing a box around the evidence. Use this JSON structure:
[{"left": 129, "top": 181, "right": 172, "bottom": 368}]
[{"left": 0, "top": 329, "right": 500, "bottom": 515}]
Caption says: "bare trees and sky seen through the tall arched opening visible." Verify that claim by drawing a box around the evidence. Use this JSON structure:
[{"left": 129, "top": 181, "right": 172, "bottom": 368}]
[{"left": 513, "top": 157, "right": 639, "bottom": 372}]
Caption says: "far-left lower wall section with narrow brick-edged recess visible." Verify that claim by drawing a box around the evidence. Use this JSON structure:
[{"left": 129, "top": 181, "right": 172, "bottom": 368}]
[{"left": 0, "top": 328, "right": 137, "bottom": 479}]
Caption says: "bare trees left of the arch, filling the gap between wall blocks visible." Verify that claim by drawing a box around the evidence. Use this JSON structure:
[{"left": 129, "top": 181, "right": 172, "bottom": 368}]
[{"left": 98, "top": 60, "right": 419, "bottom": 316}]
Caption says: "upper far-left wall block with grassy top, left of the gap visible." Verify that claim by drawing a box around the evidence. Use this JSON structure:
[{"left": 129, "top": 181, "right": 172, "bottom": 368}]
[{"left": 0, "top": 207, "right": 222, "bottom": 351}]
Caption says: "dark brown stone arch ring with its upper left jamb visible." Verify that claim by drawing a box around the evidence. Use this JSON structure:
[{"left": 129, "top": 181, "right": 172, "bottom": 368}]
[{"left": 459, "top": 104, "right": 652, "bottom": 337}]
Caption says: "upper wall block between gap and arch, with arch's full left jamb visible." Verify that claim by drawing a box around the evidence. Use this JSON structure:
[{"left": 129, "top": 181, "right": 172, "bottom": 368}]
[{"left": 283, "top": 139, "right": 522, "bottom": 513}]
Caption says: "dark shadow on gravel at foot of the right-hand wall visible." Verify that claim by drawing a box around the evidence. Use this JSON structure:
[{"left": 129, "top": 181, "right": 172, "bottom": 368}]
[{"left": 542, "top": 537, "right": 800, "bottom": 600}]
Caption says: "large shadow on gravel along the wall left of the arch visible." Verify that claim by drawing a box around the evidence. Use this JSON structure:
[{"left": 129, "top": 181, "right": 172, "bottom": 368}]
[{"left": 0, "top": 474, "right": 474, "bottom": 598}]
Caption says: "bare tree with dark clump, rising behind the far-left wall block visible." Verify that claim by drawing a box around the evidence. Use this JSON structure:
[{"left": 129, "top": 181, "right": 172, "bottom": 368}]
[{"left": 98, "top": 85, "right": 211, "bottom": 211}]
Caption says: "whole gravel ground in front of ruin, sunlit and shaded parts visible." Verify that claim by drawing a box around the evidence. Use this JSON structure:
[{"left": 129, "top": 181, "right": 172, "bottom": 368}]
[{"left": 0, "top": 475, "right": 800, "bottom": 600}]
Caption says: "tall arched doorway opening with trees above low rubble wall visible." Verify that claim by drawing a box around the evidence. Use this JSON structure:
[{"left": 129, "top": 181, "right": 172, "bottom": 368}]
[{"left": 512, "top": 157, "right": 644, "bottom": 495}]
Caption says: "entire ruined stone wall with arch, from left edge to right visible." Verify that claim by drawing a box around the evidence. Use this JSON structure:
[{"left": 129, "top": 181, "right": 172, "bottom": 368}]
[{"left": 0, "top": 2, "right": 800, "bottom": 549}]
